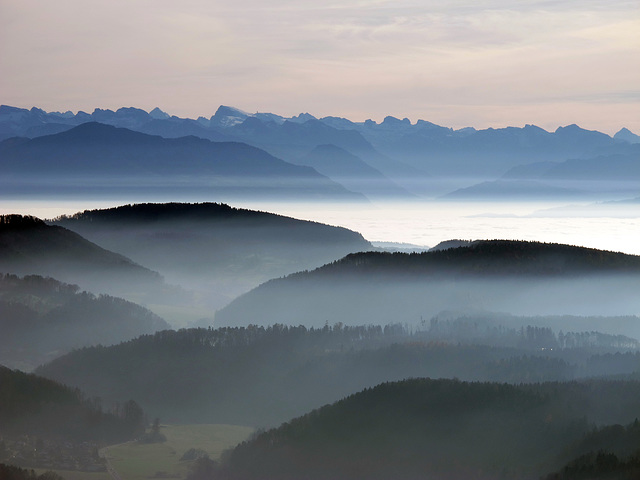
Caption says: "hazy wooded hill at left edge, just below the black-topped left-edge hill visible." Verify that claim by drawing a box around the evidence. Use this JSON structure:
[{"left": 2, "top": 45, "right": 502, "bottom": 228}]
[{"left": 0, "top": 274, "right": 169, "bottom": 370}]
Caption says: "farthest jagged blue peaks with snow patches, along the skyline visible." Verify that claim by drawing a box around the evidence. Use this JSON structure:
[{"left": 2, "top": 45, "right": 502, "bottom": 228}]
[{"left": 0, "top": 106, "right": 635, "bottom": 194}]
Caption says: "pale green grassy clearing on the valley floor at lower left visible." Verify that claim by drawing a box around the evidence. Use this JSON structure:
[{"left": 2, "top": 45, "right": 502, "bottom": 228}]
[{"left": 102, "top": 425, "right": 253, "bottom": 480}]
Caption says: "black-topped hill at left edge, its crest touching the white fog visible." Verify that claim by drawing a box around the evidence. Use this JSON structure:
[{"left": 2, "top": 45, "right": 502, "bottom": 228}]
[{"left": 0, "top": 215, "right": 163, "bottom": 293}]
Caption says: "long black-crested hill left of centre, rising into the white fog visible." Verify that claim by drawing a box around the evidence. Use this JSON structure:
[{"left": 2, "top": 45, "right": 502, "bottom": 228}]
[{"left": 54, "top": 203, "right": 372, "bottom": 309}]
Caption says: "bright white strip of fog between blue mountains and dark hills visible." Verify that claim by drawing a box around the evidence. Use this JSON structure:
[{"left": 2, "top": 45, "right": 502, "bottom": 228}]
[{"left": 0, "top": 196, "right": 640, "bottom": 255}]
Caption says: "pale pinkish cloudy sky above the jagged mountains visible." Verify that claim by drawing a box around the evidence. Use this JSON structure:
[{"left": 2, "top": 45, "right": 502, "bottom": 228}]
[{"left": 0, "top": 0, "right": 640, "bottom": 134}]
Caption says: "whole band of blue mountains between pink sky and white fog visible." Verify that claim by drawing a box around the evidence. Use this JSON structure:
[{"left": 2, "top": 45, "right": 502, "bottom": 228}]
[{"left": 0, "top": 105, "right": 640, "bottom": 200}]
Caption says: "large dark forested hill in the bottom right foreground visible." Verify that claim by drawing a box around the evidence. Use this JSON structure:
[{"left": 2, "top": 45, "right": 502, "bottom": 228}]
[{"left": 216, "top": 379, "right": 640, "bottom": 480}]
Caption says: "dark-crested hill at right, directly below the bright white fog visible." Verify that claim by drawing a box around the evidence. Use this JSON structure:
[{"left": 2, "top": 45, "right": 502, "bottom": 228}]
[{"left": 215, "top": 240, "right": 640, "bottom": 328}]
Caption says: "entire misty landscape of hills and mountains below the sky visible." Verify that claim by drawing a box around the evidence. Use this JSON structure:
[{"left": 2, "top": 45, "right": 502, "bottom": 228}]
[{"left": 0, "top": 106, "right": 640, "bottom": 480}]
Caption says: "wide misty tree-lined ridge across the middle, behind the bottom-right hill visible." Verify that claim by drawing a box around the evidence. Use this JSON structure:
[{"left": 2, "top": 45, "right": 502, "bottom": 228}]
[{"left": 37, "top": 319, "right": 640, "bottom": 426}]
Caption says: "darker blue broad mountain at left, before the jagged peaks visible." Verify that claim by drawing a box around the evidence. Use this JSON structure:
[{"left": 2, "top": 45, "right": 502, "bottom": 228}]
[{"left": 0, "top": 122, "right": 364, "bottom": 200}]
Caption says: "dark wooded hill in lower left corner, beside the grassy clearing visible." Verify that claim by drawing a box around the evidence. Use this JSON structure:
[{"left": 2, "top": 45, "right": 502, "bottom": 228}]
[{"left": 0, "top": 365, "right": 146, "bottom": 443}]
